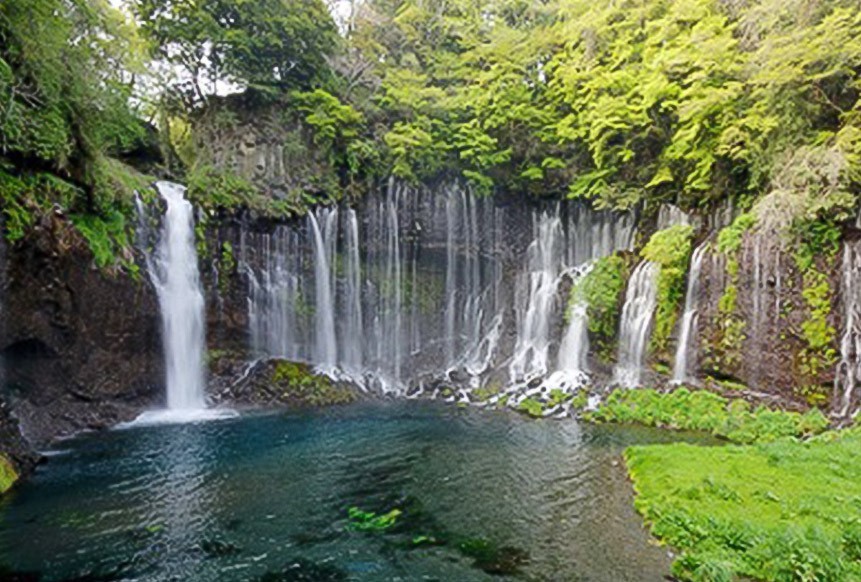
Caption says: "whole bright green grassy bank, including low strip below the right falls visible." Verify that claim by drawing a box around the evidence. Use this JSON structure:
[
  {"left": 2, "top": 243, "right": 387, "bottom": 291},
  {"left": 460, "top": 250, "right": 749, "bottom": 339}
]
[{"left": 591, "top": 389, "right": 861, "bottom": 582}]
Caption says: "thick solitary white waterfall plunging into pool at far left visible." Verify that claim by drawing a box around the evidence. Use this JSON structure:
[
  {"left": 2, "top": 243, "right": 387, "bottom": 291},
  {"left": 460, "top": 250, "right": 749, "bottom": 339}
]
[{"left": 148, "top": 182, "right": 206, "bottom": 411}]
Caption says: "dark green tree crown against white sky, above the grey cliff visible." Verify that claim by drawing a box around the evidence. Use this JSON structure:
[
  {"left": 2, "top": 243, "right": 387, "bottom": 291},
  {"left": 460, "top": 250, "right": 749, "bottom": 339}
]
[{"left": 132, "top": 0, "right": 338, "bottom": 105}]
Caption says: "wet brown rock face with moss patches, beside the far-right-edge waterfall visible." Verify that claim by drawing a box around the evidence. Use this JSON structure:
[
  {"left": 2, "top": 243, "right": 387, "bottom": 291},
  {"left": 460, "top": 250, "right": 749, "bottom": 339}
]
[{"left": 697, "top": 233, "right": 841, "bottom": 407}]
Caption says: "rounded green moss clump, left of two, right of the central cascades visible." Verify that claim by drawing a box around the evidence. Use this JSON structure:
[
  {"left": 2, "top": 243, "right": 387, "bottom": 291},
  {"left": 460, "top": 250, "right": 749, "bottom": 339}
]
[{"left": 566, "top": 255, "right": 628, "bottom": 361}]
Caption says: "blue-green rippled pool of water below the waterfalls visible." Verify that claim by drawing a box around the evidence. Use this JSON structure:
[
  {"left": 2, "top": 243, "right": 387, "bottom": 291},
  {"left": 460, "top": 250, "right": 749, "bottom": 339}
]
[{"left": 0, "top": 402, "right": 704, "bottom": 582}]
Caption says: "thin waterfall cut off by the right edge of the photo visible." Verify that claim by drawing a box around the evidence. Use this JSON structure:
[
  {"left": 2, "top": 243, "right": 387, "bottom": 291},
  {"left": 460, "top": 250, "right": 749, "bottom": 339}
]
[{"left": 834, "top": 241, "right": 861, "bottom": 417}]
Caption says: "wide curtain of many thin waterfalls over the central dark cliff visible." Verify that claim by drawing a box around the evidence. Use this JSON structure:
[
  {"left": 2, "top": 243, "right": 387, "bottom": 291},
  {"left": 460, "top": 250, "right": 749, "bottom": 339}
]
[{"left": 239, "top": 181, "right": 635, "bottom": 396}]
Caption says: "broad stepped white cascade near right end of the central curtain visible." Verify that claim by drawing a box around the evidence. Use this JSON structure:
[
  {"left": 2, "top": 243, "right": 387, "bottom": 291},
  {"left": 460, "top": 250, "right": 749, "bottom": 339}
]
[{"left": 509, "top": 210, "right": 562, "bottom": 382}]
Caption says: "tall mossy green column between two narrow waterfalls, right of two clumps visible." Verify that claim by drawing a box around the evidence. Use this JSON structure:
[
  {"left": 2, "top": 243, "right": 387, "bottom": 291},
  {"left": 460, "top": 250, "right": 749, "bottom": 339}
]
[{"left": 640, "top": 225, "right": 694, "bottom": 359}]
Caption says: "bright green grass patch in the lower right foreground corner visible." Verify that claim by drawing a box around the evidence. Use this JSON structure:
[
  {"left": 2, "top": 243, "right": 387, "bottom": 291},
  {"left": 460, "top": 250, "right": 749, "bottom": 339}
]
[{"left": 625, "top": 429, "right": 861, "bottom": 582}]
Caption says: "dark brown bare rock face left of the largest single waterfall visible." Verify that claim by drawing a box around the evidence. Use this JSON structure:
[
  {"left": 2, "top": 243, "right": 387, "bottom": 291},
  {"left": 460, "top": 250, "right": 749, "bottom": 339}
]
[{"left": 0, "top": 216, "right": 164, "bottom": 444}]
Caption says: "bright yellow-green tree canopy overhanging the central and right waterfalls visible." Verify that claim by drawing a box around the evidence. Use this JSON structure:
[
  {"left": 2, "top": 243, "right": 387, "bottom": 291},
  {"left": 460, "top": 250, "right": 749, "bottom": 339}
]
[{"left": 349, "top": 0, "right": 861, "bottom": 207}]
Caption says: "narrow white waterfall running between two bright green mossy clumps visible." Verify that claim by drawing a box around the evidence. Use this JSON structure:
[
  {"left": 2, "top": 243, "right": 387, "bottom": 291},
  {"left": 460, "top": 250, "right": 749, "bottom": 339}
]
[{"left": 614, "top": 261, "right": 660, "bottom": 388}]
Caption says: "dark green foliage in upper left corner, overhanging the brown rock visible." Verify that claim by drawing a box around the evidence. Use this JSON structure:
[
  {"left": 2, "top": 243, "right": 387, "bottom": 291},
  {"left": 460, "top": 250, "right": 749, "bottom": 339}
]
[{"left": 0, "top": 0, "right": 150, "bottom": 240}]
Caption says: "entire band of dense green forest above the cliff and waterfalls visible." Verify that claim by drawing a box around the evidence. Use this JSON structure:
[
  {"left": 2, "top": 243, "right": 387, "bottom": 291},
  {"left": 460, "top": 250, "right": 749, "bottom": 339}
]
[{"left": 5, "top": 0, "right": 861, "bottom": 251}]
